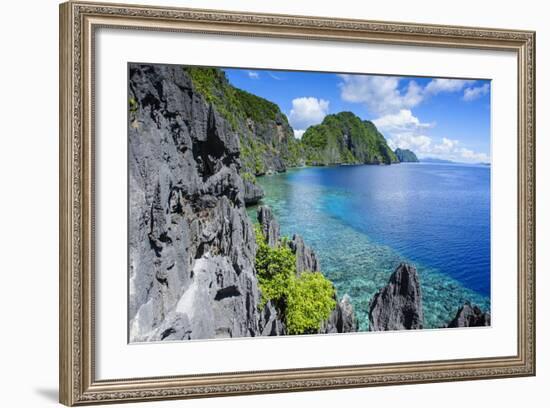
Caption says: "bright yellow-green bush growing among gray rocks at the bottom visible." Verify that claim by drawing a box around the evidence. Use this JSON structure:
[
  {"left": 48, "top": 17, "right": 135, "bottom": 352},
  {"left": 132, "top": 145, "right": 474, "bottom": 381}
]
[{"left": 255, "top": 225, "right": 336, "bottom": 334}]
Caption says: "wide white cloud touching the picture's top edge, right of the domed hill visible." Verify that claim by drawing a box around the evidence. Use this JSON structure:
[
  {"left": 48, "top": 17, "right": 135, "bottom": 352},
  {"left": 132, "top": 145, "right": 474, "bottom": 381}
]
[{"left": 339, "top": 74, "right": 475, "bottom": 115}]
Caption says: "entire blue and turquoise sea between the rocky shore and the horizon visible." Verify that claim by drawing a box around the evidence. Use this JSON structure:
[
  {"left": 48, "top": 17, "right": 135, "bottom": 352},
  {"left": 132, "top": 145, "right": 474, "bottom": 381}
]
[{"left": 248, "top": 164, "right": 490, "bottom": 330}]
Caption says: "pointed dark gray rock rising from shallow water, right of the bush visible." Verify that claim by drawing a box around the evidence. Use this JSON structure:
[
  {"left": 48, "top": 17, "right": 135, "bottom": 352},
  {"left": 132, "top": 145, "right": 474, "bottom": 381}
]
[{"left": 369, "top": 263, "right": 424, "bottom": 331}]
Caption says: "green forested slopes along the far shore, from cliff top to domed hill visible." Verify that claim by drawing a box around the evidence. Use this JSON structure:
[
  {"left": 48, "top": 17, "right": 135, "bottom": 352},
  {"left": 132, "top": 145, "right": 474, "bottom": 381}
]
[{"left": 185, "top": 67, "right": 406, "bottom": 176}]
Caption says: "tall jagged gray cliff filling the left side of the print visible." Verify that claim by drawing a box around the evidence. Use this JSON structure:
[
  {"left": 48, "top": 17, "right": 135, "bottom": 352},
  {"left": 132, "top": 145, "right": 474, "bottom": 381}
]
[{"left": 129, "top": 64, "right": 260, "bottom": 342}]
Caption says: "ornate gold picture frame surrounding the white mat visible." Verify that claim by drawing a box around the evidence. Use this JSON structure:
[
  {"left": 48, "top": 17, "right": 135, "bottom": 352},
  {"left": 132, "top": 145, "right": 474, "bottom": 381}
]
[{"left": 59, "top": 2, "right": 535, "bottom": 405}]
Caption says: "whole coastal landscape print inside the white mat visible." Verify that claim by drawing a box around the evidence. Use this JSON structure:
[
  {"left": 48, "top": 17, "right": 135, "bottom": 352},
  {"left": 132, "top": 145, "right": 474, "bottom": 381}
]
[{"left": 127, "top": 63, "right": 491, "bottom": 343}]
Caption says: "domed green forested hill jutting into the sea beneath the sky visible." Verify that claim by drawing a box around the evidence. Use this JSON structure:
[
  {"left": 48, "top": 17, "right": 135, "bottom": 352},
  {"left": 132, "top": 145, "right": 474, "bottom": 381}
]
[{"left": 302, "top": 112, "right": 398, "bottom": 165}]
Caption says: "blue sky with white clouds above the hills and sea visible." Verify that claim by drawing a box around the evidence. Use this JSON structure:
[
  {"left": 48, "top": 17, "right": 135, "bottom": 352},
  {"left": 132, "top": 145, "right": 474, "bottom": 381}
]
[{"left": 224, "top": 69, "right": 491, "bottom": 163}]
